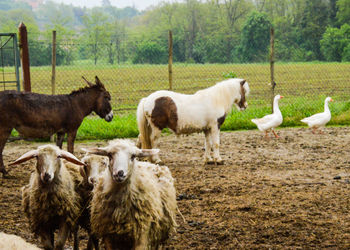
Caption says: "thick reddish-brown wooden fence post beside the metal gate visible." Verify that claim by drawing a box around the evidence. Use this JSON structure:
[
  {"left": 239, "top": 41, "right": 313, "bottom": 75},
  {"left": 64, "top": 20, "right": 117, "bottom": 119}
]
[{"left": 18, "top": 22, "right": 31, "bottom": 92}]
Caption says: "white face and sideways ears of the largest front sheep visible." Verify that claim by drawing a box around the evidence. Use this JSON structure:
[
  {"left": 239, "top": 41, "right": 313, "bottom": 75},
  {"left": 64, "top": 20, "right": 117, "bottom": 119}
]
[{"left": 87, "top": 140, "right": 159, "bottom": 183}]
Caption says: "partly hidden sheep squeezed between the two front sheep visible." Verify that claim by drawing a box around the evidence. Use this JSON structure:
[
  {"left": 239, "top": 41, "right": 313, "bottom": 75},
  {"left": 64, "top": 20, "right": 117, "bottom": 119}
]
[{"left": 66, "top": 154, "right": 108, "bottom": 250}]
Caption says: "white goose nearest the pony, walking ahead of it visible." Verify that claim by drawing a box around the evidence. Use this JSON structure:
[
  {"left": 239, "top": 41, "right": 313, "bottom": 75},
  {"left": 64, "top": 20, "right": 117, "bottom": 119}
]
[{"left": 252, "top": 95, "right": 283, "bottom": 138}]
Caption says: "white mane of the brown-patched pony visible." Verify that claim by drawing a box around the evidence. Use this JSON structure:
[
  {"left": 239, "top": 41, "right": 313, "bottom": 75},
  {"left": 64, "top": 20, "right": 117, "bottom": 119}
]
[{"left": 195, "top": 78, "right": 249, "bottom": 113}]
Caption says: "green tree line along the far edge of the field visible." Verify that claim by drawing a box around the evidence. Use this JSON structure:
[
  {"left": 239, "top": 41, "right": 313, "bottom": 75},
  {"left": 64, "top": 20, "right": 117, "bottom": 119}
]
[{"left": 0, "top": 0, "right": 350, "bottom": 65}]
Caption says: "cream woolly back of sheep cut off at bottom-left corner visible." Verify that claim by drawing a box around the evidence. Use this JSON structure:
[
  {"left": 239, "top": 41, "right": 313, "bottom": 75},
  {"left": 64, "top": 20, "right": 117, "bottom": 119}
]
[{"left": 0, "top": 232, "right": 40, "bottom": 250}]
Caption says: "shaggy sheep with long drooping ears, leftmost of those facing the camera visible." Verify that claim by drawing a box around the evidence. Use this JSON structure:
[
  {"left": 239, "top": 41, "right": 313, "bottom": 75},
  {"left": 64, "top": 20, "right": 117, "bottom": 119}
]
[{"left": 10, "top": 145, "right": 84, "bottom": 249}]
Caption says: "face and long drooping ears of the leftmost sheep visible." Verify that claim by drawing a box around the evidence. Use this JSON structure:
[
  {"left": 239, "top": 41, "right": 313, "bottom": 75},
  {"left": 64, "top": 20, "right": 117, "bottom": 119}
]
[{"left": 10, "top": 145, "right": 84, "bottom": 184}]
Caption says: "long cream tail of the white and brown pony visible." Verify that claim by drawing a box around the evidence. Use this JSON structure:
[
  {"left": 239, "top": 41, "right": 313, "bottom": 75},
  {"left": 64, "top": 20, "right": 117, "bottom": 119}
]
[{"left": 136, "top": 98, "right": 152, "bottom": 148}]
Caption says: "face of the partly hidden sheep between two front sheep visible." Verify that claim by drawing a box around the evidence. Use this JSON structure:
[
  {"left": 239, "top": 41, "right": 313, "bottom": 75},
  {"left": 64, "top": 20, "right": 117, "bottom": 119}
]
[{"left": 80, "top": 154, "right": 108, "bottom": 186}]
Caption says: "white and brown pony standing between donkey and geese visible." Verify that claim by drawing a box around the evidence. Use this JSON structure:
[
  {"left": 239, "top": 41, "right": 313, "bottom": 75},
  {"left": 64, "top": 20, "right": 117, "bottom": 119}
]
[{"left": 137, "top": 78, "right": 249, "bottom": 164}]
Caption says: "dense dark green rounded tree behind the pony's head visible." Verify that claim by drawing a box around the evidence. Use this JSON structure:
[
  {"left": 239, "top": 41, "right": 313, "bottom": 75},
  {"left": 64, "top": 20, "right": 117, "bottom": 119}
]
[{"left": 237, "top": 11, "right": 271, "bottom": 62}]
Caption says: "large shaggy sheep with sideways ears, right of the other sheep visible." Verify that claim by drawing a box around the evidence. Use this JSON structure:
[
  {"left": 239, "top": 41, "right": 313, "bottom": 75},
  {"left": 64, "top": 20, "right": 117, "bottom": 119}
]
[{"left": 84, "top": 139, "right": 177, "bottom": 249}]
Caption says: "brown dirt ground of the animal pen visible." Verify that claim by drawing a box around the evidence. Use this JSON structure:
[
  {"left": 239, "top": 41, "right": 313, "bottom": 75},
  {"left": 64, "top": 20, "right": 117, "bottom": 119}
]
[{"left": 0, "top": 127, "right": 350, "bottom": 249}]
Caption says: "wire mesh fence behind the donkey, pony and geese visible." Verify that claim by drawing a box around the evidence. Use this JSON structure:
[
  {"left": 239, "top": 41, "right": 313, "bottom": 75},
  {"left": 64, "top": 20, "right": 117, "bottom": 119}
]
[{"left": 6, "top": 30, "right": 350, "bottom": 139}]
